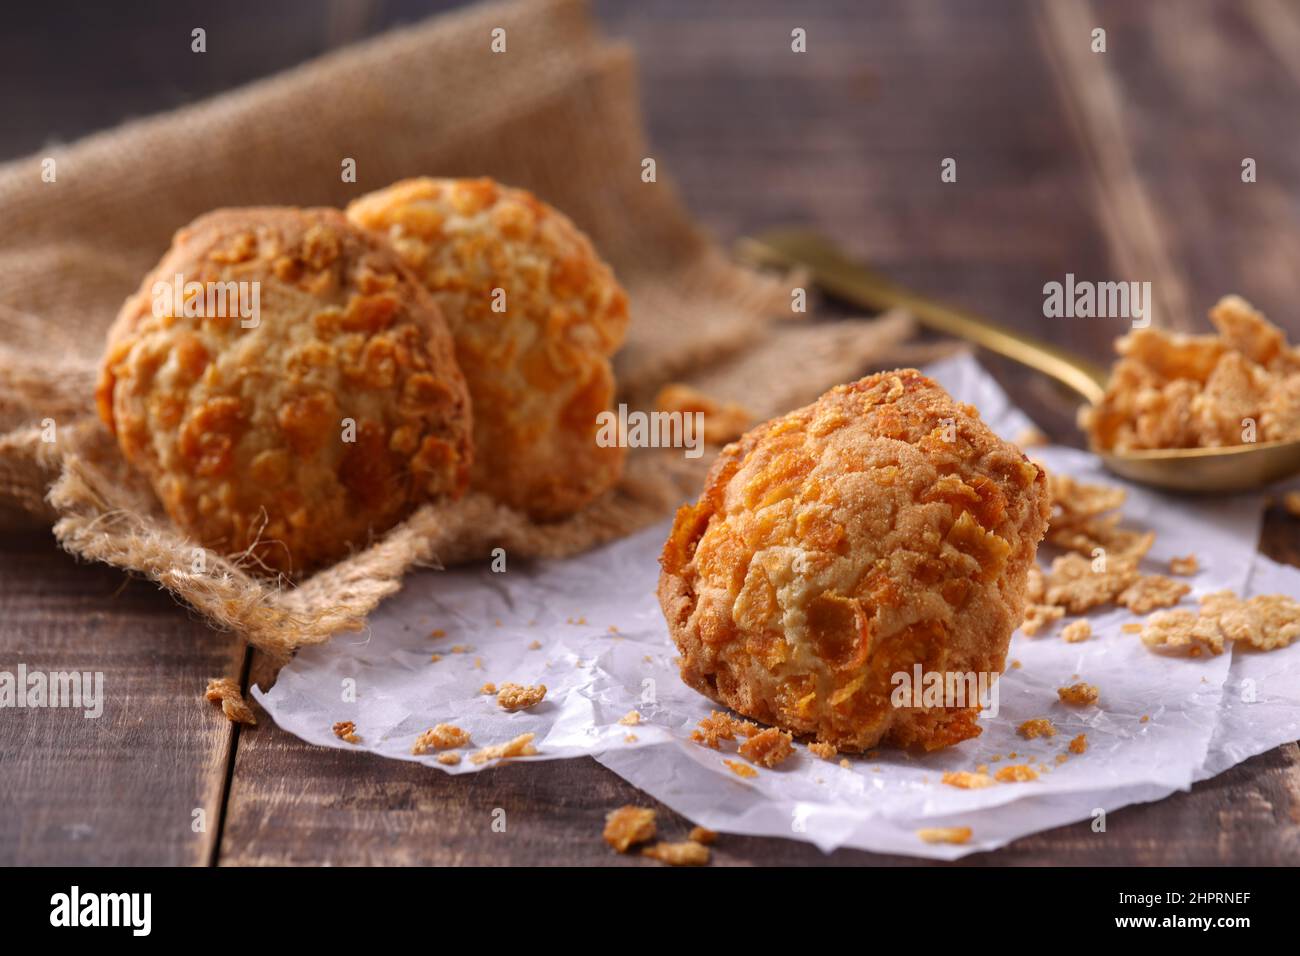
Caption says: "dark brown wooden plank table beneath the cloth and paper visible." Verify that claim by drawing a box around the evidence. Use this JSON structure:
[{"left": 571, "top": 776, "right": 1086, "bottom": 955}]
[{"left": 0, "top": 0, "right": 1300, "bottom": 865}]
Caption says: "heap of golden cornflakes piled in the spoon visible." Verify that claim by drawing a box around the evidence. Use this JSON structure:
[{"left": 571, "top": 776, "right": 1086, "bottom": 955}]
[{"left": 1079, "top": 295, "right": 1300, "bottom": 451}]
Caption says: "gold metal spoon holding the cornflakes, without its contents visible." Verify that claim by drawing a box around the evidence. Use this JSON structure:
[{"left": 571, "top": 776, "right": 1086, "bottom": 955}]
[{"left": 736, "top": 229, "right": 1300, "bottom": 493}]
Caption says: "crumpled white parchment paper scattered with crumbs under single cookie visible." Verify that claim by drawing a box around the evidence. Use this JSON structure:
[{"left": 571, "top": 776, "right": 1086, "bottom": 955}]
[{"left": 255, "top": 356, "right": 1300, "bottom": 858}]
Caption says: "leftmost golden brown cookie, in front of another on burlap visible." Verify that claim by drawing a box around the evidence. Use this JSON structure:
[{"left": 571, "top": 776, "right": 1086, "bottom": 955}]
[{"left": 96, "top": 208, "right": 473, "bottom": 572}]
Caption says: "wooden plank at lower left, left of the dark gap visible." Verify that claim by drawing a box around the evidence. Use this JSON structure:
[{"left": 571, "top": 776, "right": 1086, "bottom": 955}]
[{"left": 0, "top": 532, "right": 243, "bottom": 866}]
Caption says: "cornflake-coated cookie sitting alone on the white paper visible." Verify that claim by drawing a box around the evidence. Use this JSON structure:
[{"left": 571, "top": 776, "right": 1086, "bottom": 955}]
[{"left": 659, "top": 369, "right": 1049, "bottom": 752}]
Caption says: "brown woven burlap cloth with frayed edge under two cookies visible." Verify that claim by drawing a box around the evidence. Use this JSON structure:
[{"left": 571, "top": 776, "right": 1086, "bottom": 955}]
[{"left": 0, "top": 0, "right": 935, "bottom": 658}]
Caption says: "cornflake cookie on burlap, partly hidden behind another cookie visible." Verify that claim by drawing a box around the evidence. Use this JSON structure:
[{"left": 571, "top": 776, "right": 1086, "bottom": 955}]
[{"left": 347, "top": 178, "right": 628, "bottom": 519}]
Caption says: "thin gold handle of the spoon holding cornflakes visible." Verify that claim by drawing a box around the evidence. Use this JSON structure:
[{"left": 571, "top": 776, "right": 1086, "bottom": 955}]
[{"left": 736, "top": 229, "right": 1106, "bottom": 405}]
